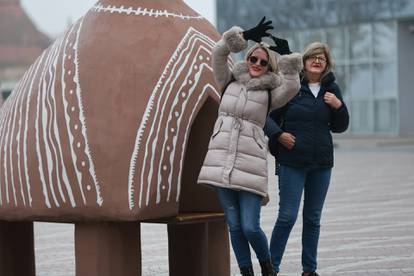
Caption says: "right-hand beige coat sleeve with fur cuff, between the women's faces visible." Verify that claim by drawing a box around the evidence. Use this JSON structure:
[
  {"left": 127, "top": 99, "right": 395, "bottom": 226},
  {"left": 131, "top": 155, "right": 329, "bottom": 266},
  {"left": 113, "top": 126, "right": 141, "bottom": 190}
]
[{"left": 271, "top": 53, "right": 303, "bottom": 109}]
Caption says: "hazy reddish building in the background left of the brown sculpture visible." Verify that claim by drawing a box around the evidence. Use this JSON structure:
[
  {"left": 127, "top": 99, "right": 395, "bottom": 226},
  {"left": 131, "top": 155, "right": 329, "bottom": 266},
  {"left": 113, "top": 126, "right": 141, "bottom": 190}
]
[{"left": 0, "top": 0, "right": 50, "bottom": 106}]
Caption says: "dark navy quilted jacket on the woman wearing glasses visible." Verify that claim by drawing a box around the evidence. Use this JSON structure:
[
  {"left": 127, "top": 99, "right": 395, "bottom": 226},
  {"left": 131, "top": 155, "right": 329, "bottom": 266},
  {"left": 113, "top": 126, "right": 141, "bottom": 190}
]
[{"left": 264, "top": 73, "right": 349, "bottom": 168}]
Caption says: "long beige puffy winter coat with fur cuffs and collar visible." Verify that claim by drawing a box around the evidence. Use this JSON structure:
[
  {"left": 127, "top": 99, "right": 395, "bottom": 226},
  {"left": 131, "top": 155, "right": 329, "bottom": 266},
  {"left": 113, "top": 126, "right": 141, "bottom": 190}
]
[{"left": 198, "top": 27, "right": 302, "bottom": 197}]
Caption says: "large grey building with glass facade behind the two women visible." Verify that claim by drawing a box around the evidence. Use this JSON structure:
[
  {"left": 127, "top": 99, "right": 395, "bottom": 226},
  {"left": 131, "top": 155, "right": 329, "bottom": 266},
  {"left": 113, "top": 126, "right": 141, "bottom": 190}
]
[{"left": 217, "top": 0, "right": 414, "bottom": 136}]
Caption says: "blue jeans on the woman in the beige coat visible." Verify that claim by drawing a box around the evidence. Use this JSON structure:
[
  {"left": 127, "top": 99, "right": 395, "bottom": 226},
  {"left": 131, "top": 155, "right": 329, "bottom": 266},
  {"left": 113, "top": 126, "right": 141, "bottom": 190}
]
[{"left": 217, "top": 188, "right": 270, "bottom": 267}]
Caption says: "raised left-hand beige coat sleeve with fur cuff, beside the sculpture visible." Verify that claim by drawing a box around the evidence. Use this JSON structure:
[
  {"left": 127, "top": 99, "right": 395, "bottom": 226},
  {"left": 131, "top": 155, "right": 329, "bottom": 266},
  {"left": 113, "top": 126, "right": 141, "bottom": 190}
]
[{"left": 211, "top": 26, "right": 247, "bottom": 91}]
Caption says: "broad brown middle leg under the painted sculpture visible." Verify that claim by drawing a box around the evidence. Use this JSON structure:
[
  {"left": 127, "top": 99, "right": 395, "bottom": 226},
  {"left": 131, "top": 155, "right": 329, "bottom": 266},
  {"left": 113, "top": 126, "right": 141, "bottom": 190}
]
[{"left": 75, "top": 222, "right": 141, "bottom": 276}]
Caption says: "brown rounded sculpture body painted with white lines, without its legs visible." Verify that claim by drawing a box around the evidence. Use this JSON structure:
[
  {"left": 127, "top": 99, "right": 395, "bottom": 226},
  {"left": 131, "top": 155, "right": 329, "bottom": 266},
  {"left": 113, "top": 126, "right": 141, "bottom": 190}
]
[{"left": 0, "top": 0, "right": 223, "bottom": 221}]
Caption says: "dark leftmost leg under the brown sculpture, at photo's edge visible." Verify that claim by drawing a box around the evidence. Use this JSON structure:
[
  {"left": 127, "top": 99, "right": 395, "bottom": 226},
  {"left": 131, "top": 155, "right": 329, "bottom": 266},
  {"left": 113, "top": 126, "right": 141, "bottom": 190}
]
[{"left": 0, "top": 221, "right": 36, "bottom": 276}]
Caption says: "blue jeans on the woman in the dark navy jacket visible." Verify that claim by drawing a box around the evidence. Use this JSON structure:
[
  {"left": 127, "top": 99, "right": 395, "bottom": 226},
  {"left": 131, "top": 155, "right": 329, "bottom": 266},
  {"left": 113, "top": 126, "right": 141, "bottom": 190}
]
[{"left": 270, "top": 165, "right": 332, "bottom": 272}]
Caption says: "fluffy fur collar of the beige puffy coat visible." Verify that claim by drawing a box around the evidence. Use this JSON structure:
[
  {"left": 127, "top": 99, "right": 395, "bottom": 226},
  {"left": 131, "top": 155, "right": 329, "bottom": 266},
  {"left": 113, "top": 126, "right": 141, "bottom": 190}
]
[{"left": 233, "top": 61, "right": 282, "bottom": 90}]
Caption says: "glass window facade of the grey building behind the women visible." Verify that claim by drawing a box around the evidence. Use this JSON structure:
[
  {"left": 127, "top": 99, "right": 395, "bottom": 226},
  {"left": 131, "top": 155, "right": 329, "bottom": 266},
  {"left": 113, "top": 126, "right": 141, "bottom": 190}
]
[{"left": 279, "top": 21, "right": 398, "bottom": 134}]
